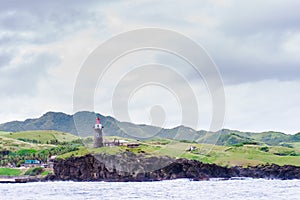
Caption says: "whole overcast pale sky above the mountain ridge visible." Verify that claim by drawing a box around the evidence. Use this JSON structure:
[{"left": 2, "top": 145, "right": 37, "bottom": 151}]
[{"left": 0, "top": 0, "right": 300, "bottom": 134}]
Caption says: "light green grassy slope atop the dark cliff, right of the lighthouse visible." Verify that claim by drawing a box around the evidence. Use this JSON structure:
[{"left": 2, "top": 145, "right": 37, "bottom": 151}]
[{"left": 56, "top": 139, "right": 300, "bottom": 166}]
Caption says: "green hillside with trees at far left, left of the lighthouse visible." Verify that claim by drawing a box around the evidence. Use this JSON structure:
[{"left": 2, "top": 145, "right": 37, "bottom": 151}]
[{"left": 0, "top": 131, "right": 82, "bottom": 166}]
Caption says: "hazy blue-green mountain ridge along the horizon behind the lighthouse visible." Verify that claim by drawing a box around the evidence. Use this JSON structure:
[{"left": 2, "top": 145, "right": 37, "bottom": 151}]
[{"left": 0, "top": 111, "right": 300, "bottom": 146}]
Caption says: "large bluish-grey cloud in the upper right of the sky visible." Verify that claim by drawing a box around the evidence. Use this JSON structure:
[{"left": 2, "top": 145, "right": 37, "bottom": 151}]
[{"left": 195, "top": 1, "right": 300, "bottom": 84}]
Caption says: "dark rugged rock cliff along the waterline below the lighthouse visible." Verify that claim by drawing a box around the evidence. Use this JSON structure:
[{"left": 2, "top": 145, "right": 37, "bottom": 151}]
[{"left": 48, "top": 152, "right": 300, "bottom": 181}]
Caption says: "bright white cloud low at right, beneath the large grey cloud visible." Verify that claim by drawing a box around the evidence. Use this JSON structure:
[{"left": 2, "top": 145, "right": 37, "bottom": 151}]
[{"left": 225, "top": 80, "right": 300, "bottom": 133}]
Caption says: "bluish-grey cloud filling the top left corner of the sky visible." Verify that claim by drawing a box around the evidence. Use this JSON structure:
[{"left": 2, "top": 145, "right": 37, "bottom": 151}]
[{"left": 0, "top": 1, "right": 108, "bottom": 44}]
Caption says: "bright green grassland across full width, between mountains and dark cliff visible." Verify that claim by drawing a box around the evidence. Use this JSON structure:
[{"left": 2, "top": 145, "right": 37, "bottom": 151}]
[{"left": 0, "top": 131, "right": 300, "bottom": 166}]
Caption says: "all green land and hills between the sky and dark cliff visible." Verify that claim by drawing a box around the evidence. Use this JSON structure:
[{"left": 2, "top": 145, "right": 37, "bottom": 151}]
[{"left": 0, "top": 112, "right": 300, "bottom": 166}]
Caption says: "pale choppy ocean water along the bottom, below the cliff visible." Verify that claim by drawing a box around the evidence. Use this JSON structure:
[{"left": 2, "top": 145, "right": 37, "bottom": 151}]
[{"left": 0, "top": 179, "right": 300, "bottom": 200}]
